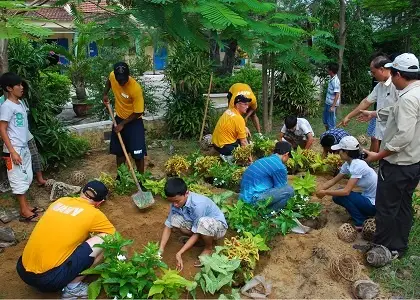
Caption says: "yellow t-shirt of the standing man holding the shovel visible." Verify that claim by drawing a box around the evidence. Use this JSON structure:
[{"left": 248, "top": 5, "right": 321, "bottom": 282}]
[{"left": 109, "top": 72, "right": 144, "bottom": 119}]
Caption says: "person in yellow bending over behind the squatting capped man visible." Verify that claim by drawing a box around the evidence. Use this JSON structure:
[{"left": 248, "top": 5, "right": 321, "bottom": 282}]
[{"left": 227, "top": 83, "right": 261, "bottom": 133}]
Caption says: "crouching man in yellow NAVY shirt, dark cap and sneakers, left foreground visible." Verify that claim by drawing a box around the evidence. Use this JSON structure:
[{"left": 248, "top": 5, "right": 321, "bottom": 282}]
[{"left": 16, "top": 180, "right": 115, "bottom": 298}]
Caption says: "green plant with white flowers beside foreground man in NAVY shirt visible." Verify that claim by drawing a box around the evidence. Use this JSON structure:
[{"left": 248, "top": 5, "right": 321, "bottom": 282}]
[{"left": 82, "top": 233, "right": 167, "bottom": 299}]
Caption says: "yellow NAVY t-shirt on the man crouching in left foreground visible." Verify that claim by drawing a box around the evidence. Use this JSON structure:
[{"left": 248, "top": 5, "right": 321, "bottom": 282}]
[{"left": 22, "top": 197, "right": 115, "bottom": 274}]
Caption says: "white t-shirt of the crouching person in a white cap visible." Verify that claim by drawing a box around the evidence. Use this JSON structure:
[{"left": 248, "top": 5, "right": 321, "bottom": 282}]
[{"left": 340, "top": 159, "right": 378, "bottom": 205}]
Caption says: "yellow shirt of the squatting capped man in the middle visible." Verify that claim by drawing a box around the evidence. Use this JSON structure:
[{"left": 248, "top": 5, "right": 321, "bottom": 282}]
[{"left": 212, "top": 108, "right": 246, "bottom": 148}]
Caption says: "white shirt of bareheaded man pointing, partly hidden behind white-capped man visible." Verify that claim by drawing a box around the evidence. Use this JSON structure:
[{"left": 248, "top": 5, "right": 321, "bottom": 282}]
[{"left": 366, "top": 77, "right": 398, "bottom": 140}]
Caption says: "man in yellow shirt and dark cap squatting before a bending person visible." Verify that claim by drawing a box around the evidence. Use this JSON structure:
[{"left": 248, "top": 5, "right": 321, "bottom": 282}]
[{"left": 212, "top": 94, "right": 251, "bottom": 156}]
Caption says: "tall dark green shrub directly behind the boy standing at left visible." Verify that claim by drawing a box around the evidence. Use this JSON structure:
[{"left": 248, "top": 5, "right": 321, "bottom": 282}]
[{"left": 8, "top": 39, "right": 89, "bottom": 168}]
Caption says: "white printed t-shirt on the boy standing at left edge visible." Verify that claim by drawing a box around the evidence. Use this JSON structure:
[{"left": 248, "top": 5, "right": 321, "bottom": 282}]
[{"left": 0, "top": 100, "right": 29, "bottom": 153}]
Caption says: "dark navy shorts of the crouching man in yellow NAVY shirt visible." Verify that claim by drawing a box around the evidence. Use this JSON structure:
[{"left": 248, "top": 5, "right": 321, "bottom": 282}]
[{"left": 16, "top": 242, "right": 95, "bottom": 293}]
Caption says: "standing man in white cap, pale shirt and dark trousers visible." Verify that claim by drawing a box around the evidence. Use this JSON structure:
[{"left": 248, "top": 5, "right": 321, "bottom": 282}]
[{"left": 362, "top": 53, "right": 420, "bottom": 256}]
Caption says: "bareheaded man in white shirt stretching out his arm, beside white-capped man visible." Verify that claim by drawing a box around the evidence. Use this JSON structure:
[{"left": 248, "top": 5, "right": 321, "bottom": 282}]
[{"left": 339, "top": 56, "right": 398, "bottom": 152}]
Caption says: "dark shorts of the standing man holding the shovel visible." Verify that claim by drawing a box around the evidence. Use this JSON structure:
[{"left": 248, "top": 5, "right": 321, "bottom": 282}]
[{"left": 109, "top": 116, "right": 147, "bottom": 159}]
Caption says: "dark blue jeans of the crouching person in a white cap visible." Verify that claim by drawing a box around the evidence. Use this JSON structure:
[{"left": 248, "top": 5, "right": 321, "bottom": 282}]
[{"left": 333, "top": 192, "right": 376, "bottom": 226}]
